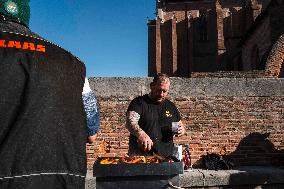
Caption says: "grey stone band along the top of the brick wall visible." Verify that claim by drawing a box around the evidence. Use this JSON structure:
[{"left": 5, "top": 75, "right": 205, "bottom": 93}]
[{"left": 89, "top": 77, "right": 284, "bottom": 99}]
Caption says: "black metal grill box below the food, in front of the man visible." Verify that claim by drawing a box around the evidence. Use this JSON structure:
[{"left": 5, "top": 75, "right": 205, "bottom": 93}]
[{"left": 93, "top": 158, "right": 183, "bottom": 189}]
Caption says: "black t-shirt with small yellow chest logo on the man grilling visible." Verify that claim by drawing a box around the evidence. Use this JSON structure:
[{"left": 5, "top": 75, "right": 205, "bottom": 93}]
[{"left": 127, "top": 95, "right": 181, "bottom": 155}]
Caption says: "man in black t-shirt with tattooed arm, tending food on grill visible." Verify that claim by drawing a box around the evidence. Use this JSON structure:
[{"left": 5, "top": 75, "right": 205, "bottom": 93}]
[{"left": 126, "top": 74, "right": 185, "bottom": 156}]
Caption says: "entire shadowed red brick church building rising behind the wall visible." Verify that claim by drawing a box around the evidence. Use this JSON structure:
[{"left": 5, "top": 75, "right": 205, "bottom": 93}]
[{"left": 148, "top": 0, "right": 284, "bottom": 77}]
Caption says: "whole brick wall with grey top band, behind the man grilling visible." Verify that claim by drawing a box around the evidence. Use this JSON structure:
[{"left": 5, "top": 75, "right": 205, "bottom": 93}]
[{"left": 87, "top": 78, "right": 284, "bottom": 168}]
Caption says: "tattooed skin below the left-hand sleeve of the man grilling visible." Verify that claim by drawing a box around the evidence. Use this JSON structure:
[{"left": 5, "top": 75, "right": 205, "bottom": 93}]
[{"left": 126, "top": 111, "right": 142, "bottom": 136}]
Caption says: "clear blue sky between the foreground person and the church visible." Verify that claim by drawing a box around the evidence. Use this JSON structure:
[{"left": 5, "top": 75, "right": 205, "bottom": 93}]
[{"left": 30, "top": 0, "right": 155, "bottom": 77}]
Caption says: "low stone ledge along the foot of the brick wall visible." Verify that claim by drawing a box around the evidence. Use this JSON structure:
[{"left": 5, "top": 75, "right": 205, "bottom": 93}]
[{"left": 86, "top": 166, "right": 284, "bottom": 189}]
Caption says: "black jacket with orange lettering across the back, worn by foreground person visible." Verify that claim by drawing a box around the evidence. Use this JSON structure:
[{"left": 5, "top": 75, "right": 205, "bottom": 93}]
[{"left": 0, "top": 22, "right": 86, "bottom": 189}]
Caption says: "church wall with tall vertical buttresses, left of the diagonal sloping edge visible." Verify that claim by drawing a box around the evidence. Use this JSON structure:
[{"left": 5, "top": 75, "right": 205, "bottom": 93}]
[{"left": 148, "top": 0, "right": 269, "bottom": 77}]
